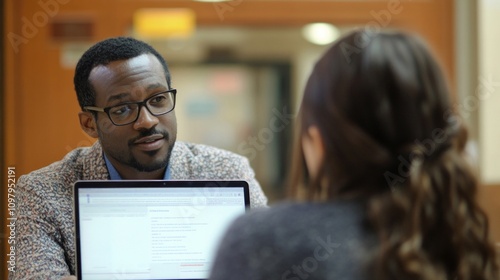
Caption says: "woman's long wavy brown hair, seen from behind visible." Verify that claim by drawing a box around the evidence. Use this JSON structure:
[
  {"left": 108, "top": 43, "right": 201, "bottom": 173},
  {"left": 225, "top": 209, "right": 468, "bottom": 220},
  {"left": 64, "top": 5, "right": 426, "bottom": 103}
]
[{"left": 291, "top": 30, "right": 499, "bottom": 280}]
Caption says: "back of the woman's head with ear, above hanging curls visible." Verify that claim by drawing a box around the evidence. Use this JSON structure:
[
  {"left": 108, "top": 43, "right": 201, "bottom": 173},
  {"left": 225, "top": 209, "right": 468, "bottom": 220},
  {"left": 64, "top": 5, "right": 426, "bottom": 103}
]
[{"left": 300, "top": 31, "right": 456, "bottom": 198}]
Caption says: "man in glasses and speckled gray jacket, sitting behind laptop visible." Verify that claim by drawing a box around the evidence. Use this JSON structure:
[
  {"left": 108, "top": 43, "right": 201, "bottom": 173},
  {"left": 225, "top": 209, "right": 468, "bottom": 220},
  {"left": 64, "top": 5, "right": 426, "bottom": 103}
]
[{"left": 9, "top": 37, "right": 267, "bottom": 279}]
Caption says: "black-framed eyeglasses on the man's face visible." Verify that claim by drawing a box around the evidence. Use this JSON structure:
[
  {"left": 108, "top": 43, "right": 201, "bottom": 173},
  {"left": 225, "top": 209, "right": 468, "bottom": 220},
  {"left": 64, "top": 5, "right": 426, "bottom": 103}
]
[{"left": 83, "top": 89, "right": 177, "bottom": 126}]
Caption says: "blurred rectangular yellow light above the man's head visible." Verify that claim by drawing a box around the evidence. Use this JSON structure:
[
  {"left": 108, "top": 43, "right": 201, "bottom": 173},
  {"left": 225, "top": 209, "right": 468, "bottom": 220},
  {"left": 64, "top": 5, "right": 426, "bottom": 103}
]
[{"left": 134, "top": 8, "right": 196, "bottom": 38}]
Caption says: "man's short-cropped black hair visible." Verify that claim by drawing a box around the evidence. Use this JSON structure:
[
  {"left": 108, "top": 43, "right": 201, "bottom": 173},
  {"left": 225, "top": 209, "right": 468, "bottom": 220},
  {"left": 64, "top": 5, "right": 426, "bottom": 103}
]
[{"left": 73, "top": 37, "right": 170, "bottom": 110}]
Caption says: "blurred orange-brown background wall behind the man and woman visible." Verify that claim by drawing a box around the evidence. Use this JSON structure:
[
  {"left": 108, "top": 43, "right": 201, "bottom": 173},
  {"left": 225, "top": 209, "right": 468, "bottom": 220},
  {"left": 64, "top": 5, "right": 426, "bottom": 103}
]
[{"left": 0, "top": 0, "right": 500, "bottom": 279}]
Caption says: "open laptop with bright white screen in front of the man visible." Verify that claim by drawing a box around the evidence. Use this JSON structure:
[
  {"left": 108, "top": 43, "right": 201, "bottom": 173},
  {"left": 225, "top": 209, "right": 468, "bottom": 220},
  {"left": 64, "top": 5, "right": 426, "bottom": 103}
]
[{"left": 74, "top": 180, "right": 250, "bottom": 280}]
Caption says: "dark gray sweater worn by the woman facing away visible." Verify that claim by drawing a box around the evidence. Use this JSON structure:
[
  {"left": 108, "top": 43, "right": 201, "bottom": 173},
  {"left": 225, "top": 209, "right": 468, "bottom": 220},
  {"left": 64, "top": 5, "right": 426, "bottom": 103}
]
[{"left": 210, "top": 201, "right": 377, "bottom": 280}]
